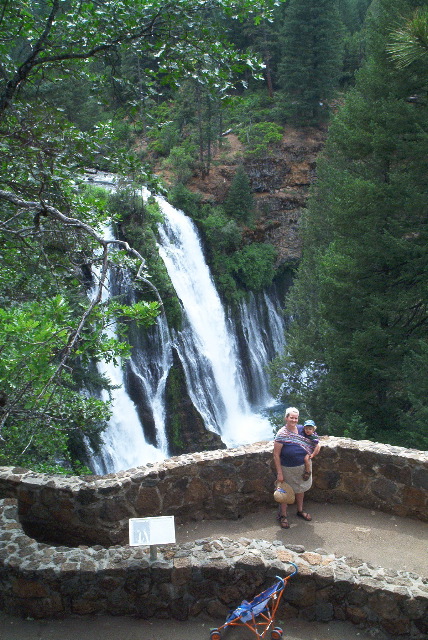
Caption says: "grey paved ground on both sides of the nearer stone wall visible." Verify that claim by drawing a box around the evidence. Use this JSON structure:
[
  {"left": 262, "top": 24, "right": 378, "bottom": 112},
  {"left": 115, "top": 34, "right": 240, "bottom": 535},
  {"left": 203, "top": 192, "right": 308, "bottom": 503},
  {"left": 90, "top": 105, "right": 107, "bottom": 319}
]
[{"left": 0, "top": 502, "right": 428, "bottom": 640}]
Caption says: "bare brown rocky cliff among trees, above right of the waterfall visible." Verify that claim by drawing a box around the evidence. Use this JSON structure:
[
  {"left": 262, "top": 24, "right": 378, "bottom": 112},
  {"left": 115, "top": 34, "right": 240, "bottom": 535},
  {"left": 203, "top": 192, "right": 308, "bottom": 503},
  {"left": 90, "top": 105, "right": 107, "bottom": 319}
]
[{"left": 189, "top": 127, "right": 326, "bottom": 265}]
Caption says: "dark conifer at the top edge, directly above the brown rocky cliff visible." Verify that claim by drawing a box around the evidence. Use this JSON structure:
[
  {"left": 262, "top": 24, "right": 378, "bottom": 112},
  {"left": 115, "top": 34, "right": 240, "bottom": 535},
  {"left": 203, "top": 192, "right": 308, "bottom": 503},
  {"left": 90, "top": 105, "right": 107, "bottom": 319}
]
[{"left": 279, "top": 0, "right": 343, "bottom": 124}]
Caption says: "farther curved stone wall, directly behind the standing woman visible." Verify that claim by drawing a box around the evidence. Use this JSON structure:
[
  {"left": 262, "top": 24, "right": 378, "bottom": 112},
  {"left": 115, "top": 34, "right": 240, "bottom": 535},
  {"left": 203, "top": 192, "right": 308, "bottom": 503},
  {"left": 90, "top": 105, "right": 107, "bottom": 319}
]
[{"left": 0, "top": 437, "right": 428, "bottom": 546}]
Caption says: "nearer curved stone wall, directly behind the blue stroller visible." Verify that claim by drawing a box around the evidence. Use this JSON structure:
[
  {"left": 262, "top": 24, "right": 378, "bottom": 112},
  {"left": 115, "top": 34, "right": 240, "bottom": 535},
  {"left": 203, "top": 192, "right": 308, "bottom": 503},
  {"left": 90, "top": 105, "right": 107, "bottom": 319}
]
[{"left": 0, "top": 498, "right": 428, "bottom": 640}]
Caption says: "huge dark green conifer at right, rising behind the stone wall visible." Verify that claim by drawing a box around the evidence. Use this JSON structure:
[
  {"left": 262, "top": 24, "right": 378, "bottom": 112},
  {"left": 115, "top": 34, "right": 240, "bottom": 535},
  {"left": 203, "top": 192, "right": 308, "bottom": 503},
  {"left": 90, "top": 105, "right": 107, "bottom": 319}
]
[{"left": 283, "top": 0, "right": 428, "bottom": 448}]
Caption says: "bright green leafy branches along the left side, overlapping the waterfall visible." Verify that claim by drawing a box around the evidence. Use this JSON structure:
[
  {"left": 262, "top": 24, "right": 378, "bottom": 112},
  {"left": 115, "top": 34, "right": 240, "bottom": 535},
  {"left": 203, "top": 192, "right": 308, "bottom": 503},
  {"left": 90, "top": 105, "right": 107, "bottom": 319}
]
[{"left": 0, "top": 0, "right": 274, "bottom": 471}]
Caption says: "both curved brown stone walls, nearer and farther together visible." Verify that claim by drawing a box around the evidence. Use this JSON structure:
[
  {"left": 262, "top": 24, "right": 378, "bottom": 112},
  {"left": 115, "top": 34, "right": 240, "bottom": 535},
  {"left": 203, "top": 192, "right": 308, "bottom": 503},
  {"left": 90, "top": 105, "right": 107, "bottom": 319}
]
[{"left": 0, "top": 438, "right": 428, "bottom": 640}]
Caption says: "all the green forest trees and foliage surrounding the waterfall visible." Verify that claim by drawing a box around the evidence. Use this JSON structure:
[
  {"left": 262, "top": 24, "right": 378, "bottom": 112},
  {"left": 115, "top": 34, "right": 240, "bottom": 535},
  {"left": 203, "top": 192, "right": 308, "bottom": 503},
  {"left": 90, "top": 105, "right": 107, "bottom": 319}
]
[{"left": 0, "top": 0, "right": 428, "bottom": 472}]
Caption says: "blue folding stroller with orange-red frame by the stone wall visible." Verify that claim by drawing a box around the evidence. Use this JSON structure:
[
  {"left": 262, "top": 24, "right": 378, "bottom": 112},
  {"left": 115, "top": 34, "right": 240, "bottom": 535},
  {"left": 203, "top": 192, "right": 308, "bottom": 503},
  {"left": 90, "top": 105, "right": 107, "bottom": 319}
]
[{"left": 210, "top": 562, "right": 298, "bottom": 640}]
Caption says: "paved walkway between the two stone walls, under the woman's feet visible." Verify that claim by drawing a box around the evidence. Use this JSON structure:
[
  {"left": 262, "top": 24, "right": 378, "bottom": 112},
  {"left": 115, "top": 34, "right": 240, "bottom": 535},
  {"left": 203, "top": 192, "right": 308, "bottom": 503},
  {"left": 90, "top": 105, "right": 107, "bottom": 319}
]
[{"left": 176, "top": 501, "right": 428, "bottom": 578}]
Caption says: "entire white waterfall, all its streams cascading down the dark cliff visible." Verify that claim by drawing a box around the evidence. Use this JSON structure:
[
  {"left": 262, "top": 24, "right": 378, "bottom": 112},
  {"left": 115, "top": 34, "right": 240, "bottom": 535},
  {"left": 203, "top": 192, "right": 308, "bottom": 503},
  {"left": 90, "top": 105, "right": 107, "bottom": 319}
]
[{"left": 84, "top": 176, "right": 284, "bottom": 474}]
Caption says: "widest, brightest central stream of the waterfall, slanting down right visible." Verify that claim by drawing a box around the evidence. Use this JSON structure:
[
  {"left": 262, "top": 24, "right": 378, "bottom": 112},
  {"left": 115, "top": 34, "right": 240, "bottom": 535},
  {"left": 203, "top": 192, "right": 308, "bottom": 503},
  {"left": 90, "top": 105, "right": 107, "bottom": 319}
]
[{"left": 157, "top": 197, "right": 272, "bottom": 446}]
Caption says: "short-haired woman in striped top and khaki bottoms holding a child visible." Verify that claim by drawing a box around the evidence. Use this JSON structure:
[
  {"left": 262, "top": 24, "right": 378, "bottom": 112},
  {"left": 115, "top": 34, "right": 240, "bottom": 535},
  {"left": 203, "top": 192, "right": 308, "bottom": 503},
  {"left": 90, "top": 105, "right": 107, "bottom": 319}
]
[{"left": 273, "top": 407, "right": 312, "bottom": 529}]
